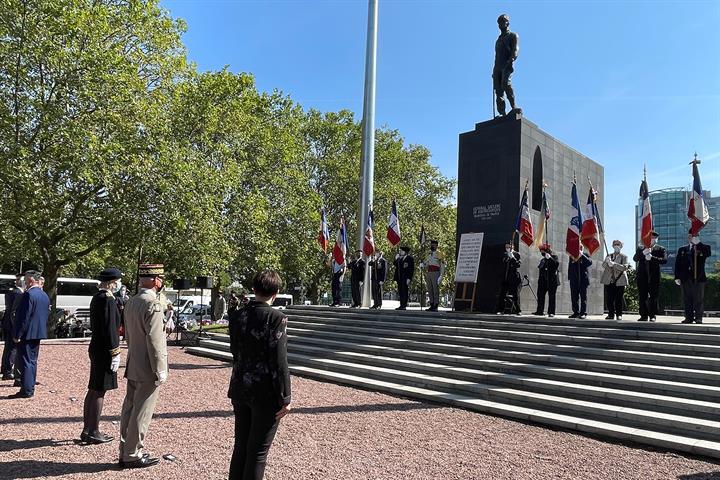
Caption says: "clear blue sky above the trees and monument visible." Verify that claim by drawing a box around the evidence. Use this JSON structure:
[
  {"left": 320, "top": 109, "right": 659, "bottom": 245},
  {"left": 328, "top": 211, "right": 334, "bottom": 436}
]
[{"left": 163, "top": 0, "right": 720, "bottom": 251}]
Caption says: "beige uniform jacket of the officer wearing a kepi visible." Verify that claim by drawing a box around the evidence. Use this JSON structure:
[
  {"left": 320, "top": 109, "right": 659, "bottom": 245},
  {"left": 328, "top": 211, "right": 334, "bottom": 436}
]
[{"left": 125, "top": 288, "right": 168, "bottom": 382}]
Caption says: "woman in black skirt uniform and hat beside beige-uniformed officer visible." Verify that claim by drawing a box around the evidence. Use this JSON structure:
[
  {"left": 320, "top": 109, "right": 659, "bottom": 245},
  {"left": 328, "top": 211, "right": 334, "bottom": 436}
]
[{"left": 80, "top": 268, "right": 122, "bottom": 444}]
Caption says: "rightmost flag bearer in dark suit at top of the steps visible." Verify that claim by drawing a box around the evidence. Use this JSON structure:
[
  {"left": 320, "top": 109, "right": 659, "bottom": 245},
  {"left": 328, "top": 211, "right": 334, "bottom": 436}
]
[{"left": 675, "top": 229, "right": 712, "bottom": 323}]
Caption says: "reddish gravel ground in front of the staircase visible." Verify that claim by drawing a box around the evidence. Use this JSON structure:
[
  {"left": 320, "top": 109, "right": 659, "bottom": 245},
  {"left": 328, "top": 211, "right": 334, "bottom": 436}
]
[{"left": 0, "top": 344, "right": 720, "bottom": 480}]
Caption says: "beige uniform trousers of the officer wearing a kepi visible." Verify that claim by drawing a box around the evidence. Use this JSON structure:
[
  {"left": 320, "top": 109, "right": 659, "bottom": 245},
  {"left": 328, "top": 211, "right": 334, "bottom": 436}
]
[{"left": 120, "top": 379, "right": 160, "bottom": 462}]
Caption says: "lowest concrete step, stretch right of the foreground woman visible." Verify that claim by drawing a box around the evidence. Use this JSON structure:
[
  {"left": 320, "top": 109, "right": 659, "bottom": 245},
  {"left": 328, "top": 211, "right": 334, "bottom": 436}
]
[{"left": 290, "top": 365, "right": 720, "bottom": 458}]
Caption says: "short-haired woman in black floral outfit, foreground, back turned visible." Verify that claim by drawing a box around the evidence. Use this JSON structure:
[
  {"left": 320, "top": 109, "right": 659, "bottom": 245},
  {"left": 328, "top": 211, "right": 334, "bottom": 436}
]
[{"left": 228, "top": 270, "right": 290, "bottom": 480}]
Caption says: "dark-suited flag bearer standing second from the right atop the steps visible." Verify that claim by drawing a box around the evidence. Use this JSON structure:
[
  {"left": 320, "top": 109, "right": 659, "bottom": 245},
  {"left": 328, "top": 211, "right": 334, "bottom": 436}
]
[{"left": 633, "top": 231, "right": 667, "bottom": 322}]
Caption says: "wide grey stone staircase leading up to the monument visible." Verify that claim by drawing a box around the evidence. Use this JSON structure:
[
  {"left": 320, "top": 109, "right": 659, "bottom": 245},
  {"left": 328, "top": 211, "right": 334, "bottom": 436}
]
[{"left": 188, "top": 306, "right": 720, "bottom": 458}]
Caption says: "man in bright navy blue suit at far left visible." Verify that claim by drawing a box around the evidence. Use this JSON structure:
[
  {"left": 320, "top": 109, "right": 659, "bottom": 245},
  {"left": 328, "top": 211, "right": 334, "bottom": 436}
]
[{"left": 9, "top": 270, "right": 50, "bottom": 398}]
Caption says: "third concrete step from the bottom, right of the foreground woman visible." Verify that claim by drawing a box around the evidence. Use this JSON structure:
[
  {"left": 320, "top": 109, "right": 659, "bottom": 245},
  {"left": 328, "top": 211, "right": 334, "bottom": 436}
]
[{"left": 291, "top": 344, "right": 720, "bottom": 420}]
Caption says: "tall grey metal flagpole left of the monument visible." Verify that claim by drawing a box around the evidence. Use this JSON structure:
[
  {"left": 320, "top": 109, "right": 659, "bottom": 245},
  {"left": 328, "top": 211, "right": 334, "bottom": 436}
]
[{"left": 358, "top": 0, "right": 378, "bottom": 307}]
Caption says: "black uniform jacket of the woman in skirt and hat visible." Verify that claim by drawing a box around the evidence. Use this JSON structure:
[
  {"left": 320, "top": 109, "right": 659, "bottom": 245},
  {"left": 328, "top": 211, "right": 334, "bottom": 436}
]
[{"left": 88, "top": 290, "right": 120, "bottom": 368}]
